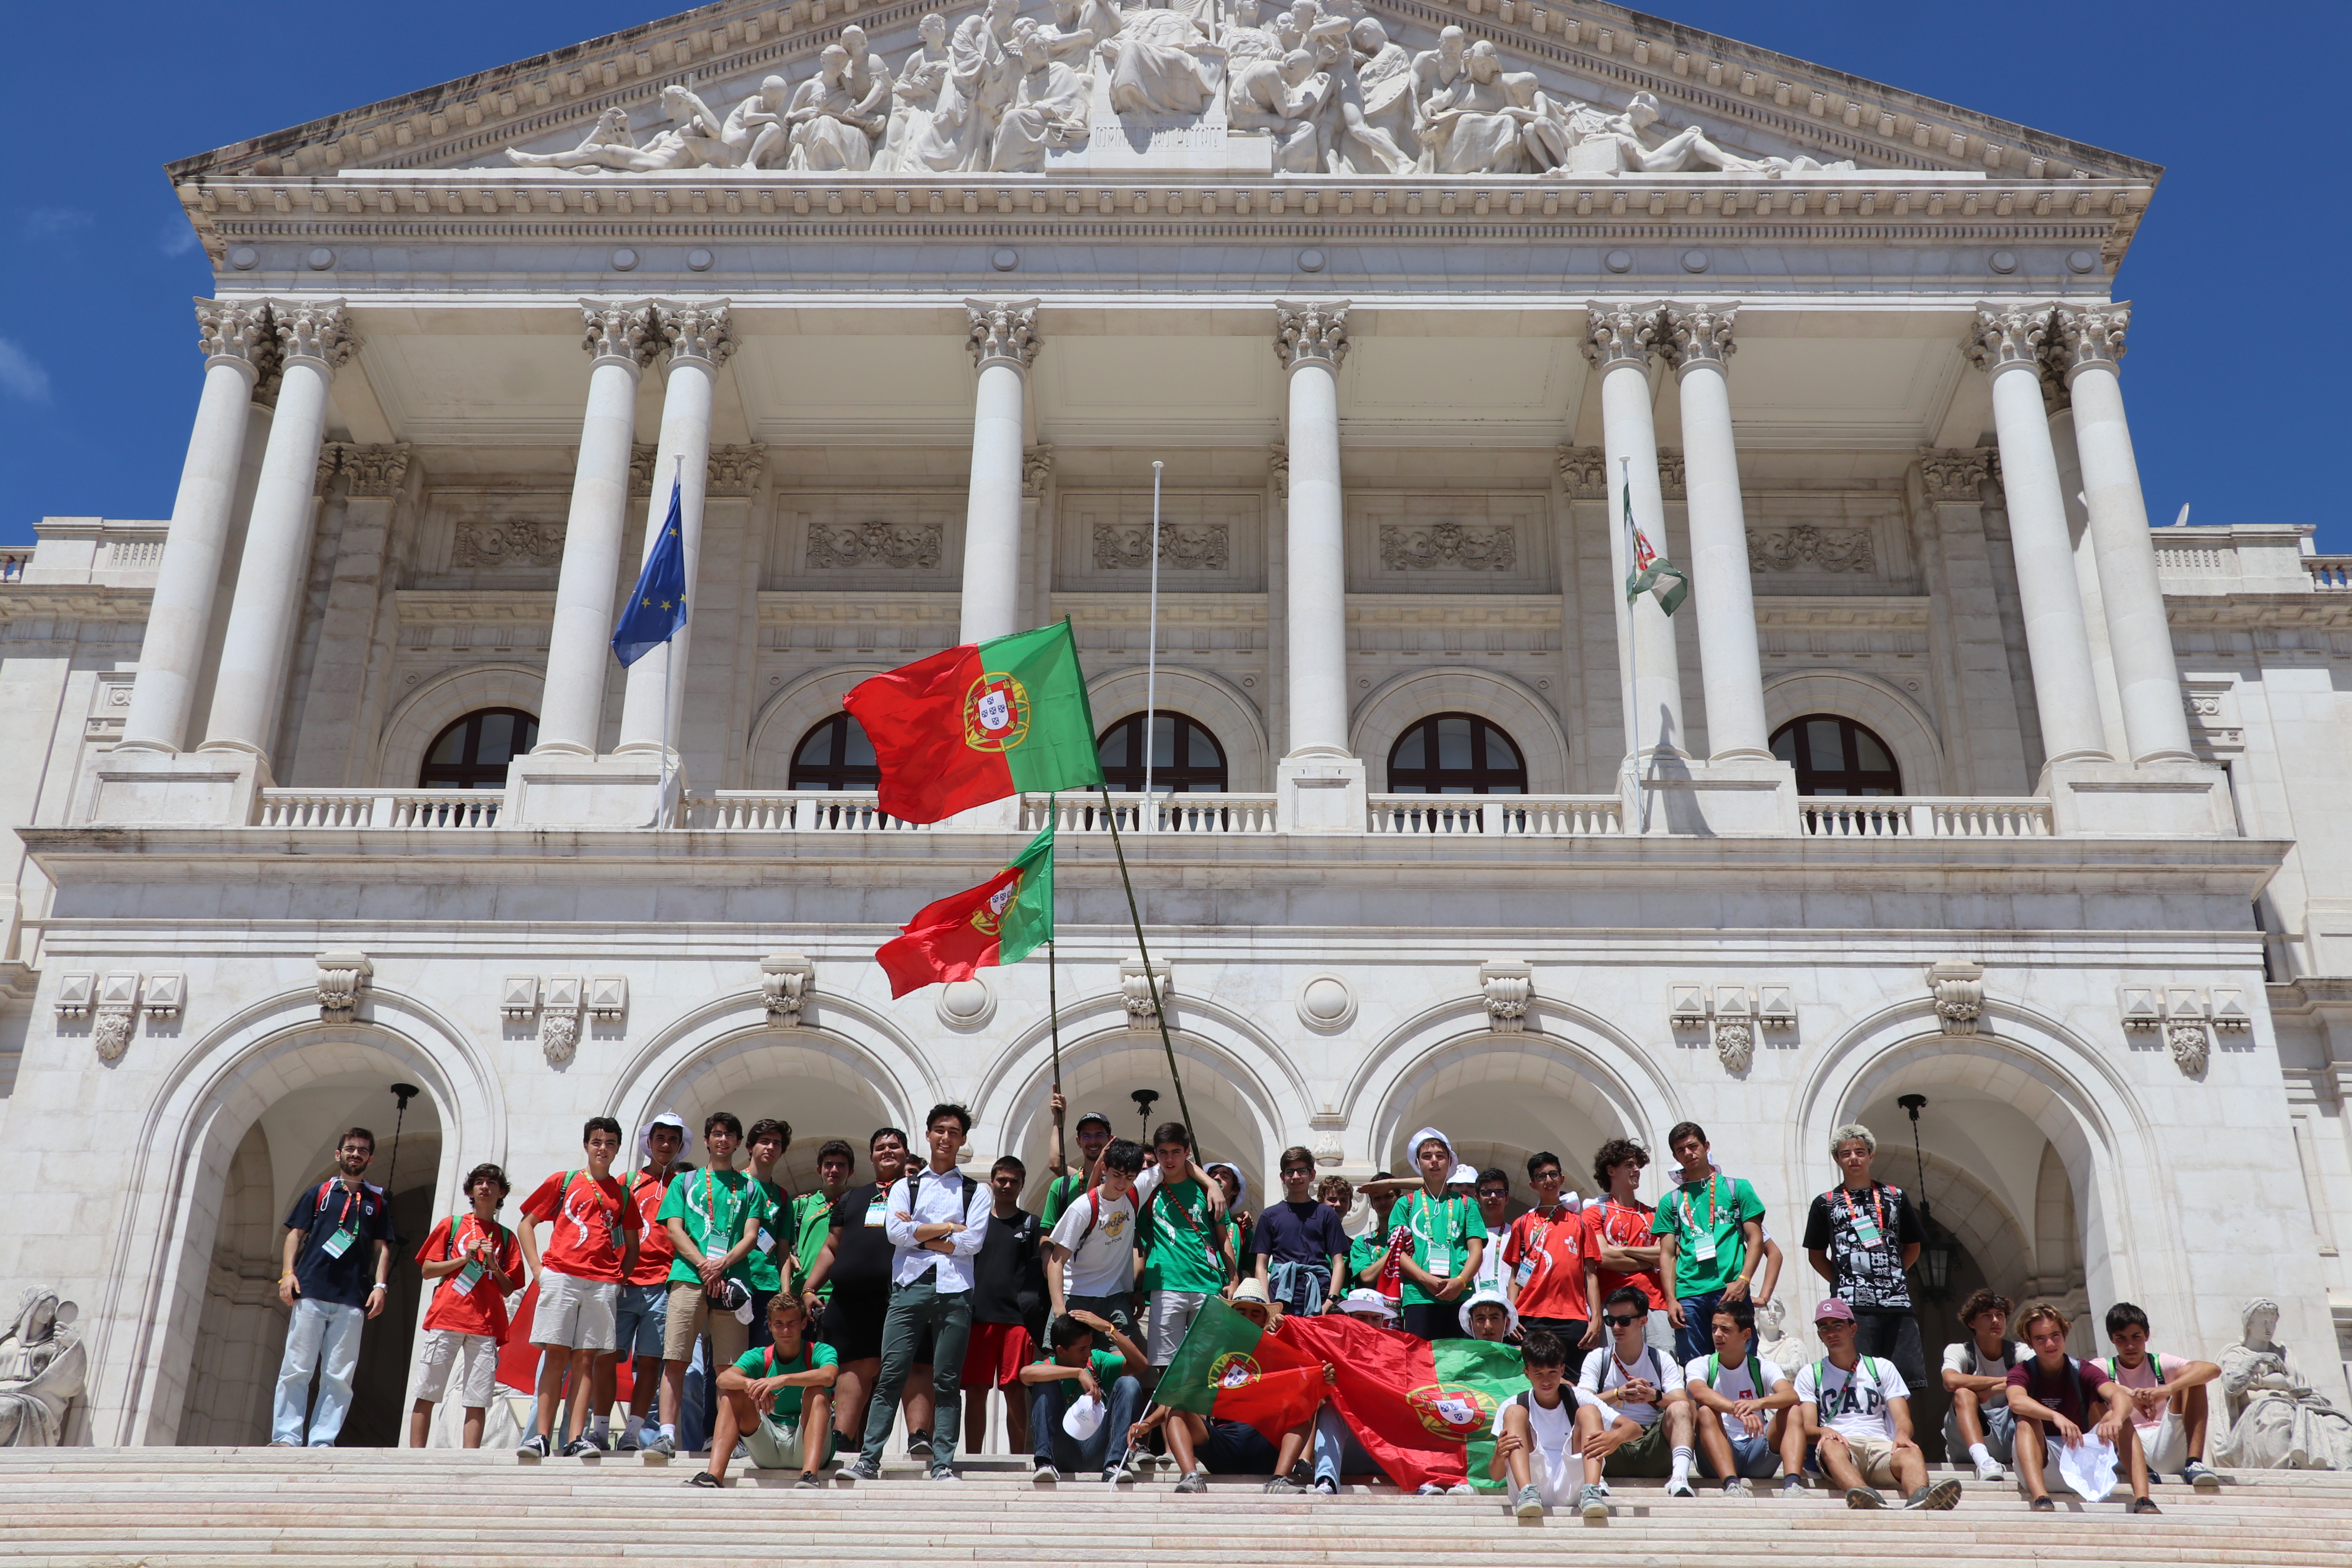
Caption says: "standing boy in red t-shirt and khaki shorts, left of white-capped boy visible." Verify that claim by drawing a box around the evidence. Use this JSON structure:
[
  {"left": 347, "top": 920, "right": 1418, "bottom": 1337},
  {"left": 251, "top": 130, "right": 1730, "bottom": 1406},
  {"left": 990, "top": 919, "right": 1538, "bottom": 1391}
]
[{"left": 520, "top": 1116, "right": 638, "bottom": 1460}]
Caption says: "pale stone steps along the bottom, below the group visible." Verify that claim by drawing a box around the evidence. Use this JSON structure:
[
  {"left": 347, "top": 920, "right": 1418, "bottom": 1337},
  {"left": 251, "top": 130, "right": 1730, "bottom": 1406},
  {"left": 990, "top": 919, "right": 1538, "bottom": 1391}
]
[{"left": 0, "top": 1448, "right": 2352, "bottom": 1568}]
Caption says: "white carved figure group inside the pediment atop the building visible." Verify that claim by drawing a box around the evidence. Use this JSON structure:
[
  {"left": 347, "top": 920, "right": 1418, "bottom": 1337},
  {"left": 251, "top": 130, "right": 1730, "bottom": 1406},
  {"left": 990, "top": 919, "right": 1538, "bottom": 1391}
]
[{"left": 508, "top": 0, "right": 1853, "bottom": 179}]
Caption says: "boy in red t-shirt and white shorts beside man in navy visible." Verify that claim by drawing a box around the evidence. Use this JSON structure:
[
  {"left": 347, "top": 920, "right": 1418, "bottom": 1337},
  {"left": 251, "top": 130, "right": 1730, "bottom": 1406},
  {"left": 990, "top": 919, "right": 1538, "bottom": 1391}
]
[{"left": 409, "top": 1166, "right": 522, "bottom": 1448}]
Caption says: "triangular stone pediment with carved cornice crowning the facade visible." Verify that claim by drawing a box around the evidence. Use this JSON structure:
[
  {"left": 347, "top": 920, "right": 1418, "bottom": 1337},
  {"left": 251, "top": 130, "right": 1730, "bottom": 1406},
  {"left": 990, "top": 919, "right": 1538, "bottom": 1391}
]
[{"left": 169, "top": 0, "right": 2159, "bottom": 186}]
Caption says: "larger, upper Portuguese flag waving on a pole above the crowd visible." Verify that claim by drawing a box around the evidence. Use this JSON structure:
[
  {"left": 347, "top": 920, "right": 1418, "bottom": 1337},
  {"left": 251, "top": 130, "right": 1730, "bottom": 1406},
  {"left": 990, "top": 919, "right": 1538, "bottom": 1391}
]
[{"left": 842, "top": 620, "right": 1103, "bottom": 823}]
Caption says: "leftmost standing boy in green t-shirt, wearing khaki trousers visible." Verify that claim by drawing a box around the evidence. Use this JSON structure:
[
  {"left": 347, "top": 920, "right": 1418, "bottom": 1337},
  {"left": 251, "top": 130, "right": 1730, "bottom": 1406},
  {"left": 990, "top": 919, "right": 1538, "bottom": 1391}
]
[{"left": 647, "top": 1110, "right": 760, "bottom": 1453}]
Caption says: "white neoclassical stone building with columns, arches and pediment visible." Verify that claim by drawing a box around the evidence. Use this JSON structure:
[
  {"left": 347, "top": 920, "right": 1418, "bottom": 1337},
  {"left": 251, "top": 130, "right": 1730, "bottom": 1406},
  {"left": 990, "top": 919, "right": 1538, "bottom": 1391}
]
[{"left": 0, "top": 0, "right": 2352, "bottom": 1443}]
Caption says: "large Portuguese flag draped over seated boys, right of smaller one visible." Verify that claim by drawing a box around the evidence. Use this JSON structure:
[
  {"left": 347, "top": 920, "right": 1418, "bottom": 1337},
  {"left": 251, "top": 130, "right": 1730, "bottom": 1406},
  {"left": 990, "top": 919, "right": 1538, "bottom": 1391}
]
[{"left": 1282, "top": 1317, "right": 1527, "bottom": 1493}]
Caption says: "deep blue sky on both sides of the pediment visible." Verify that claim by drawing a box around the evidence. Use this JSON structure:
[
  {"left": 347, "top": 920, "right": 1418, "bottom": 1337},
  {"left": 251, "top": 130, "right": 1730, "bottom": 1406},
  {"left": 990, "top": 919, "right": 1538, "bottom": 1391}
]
[{"left": 0, "top": 0, "right": 2352, "bottom": 550}]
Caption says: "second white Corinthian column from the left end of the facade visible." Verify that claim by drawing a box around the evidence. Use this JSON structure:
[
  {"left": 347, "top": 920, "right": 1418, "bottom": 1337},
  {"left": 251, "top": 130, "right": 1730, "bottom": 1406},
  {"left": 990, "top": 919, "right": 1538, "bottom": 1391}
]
[{"left": 205, "top": 299, "right": 358, "bottom": 762}]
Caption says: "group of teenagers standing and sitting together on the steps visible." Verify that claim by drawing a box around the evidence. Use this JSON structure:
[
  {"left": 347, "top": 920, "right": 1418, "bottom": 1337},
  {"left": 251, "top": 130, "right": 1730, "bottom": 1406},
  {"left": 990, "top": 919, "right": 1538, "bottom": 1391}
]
[{"left": 273, "top": 1093, "right": 2220, "bottom": 1516}]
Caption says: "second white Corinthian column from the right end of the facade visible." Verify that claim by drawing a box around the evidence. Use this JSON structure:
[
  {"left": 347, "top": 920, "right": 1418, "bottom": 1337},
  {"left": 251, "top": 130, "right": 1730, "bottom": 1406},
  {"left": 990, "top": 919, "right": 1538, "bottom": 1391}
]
[{"left": 1969, "top": 306, "right": 2108, "bottom": 764}]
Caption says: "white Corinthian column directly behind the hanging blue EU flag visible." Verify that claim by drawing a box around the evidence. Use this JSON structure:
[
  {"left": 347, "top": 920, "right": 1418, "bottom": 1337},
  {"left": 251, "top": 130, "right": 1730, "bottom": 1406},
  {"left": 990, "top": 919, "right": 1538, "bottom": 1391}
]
[{"left": 616, "top": 301, "right": 736, "bottom": 754}]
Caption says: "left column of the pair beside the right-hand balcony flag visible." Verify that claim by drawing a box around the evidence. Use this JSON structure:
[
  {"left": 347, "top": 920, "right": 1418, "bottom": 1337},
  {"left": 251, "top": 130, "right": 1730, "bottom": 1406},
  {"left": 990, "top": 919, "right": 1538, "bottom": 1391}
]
[{"left": 1585, "top": 306, "right": 1684, "bottom": 759}]
